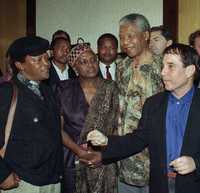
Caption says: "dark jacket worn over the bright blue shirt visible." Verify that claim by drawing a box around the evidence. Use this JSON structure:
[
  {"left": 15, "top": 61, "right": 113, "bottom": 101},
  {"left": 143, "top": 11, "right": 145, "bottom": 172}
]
[{"left": 102, "top": 89, "right": 200, "bottom": 193}]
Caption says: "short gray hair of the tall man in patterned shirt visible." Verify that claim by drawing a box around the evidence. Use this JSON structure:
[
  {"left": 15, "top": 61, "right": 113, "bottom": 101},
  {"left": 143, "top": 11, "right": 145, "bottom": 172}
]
[{"left": 119, "top": 13, "right": 151, "bottom": 32}]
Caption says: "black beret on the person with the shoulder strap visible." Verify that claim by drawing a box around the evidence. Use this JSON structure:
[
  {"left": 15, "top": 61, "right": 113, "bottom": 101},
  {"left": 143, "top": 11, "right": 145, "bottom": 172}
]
[{"left": 8, "top": 36, "right": 49, "bottom": 61}]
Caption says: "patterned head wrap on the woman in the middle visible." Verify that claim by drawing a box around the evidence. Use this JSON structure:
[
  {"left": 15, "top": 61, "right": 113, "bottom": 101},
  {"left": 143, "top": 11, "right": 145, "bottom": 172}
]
[{"left": 67, "top": 43, "right": 91, "bottom": 67}]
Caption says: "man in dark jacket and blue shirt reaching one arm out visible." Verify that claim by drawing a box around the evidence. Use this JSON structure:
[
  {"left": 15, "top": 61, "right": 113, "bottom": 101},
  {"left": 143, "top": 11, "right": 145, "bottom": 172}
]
[{"left": 86, "top": 44, "right": 200, "bottom": 193}]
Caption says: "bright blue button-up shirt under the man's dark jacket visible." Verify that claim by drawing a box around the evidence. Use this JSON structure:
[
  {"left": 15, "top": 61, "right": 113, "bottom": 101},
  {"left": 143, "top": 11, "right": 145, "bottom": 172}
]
[{"left": 166, "top": 87, "right": 194, "bottom": 171}]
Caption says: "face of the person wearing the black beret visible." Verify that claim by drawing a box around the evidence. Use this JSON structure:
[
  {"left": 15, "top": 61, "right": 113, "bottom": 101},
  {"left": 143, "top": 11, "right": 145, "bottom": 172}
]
[{"left": 16, "top": 53, "right": 50, "bottom": 81}]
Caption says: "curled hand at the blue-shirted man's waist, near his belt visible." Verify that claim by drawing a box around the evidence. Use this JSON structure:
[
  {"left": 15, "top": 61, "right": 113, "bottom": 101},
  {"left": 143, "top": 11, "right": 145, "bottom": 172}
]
[{"left": 170, "top": 156, "right": 196, "bottom": 175}]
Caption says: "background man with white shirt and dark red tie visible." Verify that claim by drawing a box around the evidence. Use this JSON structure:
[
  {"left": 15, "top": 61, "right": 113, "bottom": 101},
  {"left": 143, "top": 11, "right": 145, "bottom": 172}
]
[{"left": 97, "top": 33, "right": 118, "bottom": 80}]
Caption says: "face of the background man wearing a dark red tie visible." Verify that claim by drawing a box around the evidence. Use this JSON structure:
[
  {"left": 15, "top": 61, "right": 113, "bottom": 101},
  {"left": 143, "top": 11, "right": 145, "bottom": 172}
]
[{"left": 98, "top": 38, "right": 117, "bottom": 65}]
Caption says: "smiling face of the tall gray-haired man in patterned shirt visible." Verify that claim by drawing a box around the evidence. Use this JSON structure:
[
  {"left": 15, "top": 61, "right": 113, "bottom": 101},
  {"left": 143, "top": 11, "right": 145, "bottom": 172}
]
[{"left": 119, "top": 23, "right": 149, "bottom": 58}]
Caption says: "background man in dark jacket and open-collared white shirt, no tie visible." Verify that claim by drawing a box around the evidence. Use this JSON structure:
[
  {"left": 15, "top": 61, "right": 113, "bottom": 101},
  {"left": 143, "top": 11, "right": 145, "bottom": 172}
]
[{"left": 45, "top": 37, "right": 76, "bottom": 87}]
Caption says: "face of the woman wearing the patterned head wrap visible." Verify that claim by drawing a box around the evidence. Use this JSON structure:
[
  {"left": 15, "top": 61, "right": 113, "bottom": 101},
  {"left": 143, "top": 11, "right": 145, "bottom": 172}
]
[{"left": 74, "top": 51, "right": 99, "bottom": 78}]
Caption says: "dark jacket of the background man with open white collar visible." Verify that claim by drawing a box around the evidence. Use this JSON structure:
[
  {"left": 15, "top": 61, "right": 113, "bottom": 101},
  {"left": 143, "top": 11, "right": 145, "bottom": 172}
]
[{"left": 44, "top": 60, "right": 76, "bottom": 88}]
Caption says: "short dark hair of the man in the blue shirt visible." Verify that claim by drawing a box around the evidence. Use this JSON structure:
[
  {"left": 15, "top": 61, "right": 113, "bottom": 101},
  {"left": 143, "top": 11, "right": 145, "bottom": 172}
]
[{"left": 163, "top": 43, "right": 200, "bottom": 82}]
